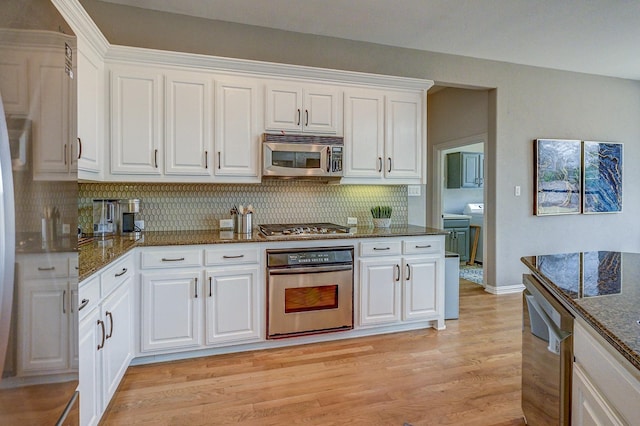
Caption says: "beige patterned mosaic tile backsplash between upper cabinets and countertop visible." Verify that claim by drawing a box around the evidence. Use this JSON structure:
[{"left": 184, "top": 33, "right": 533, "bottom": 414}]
[{"left": 78, "top": 180, "right": 408, "bottom": 233}]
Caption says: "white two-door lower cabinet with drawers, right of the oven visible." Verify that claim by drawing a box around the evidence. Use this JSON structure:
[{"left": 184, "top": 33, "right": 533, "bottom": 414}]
[{"left": 359, "top": 237, "right": 444, "bottom": 329}]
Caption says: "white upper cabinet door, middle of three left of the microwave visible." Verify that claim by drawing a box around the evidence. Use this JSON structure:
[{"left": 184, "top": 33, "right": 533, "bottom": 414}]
[{"left": 165, "top": 73, "right": 213, "bottom": 176}]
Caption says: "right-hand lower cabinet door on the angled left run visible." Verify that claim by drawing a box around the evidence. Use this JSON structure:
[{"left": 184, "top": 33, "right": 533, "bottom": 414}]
[{"left": 101, "top": 278, "right": 133, "bottom": 408}]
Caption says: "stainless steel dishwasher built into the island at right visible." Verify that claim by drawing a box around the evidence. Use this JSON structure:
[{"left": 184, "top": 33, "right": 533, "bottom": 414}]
[{"left": 522, "top": 274, "right": 573, "bottom": 426}]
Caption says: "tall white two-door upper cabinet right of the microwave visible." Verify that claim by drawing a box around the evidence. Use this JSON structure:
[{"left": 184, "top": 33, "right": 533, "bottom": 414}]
[{"left": 343, "top": 89, "right": 426, "bottom": 184}]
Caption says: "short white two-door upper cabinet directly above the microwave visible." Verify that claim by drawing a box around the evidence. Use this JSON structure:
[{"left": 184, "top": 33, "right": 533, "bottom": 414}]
[{"left": 265, "top": 83, "right": 342, "bottom": 135}]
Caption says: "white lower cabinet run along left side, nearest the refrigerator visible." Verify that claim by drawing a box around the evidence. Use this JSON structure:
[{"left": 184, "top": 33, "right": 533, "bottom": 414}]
[{"left": 79, "top": 255, "right": 134, "bottom": 425}]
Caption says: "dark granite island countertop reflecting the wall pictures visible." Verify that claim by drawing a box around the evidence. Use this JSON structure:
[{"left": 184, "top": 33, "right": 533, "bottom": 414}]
[{"left": 521, "top": 251, "right": 640, "bottom": 370}]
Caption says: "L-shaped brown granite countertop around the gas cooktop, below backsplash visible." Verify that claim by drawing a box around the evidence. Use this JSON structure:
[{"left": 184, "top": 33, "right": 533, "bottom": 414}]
[{"left": 78, "top": 225, "right": 448, "bottom": 281}]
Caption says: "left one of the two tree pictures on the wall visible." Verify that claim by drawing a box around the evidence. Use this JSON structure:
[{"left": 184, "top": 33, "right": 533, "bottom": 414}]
[{"left": 533, "top": 139, "right": 582, "bottom": 216}]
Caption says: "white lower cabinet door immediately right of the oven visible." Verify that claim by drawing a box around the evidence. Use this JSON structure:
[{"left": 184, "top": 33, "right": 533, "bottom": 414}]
[{"left": 360, "top": 257, "right": 401, "bottom": 325}]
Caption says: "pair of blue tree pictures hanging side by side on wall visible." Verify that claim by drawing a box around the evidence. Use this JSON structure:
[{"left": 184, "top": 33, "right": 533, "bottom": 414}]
[{"left": 533, "top": 139, "right": 622, "bottom": 216}]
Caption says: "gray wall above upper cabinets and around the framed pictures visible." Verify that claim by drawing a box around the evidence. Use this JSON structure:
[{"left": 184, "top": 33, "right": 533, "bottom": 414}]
[{"left": 82, "top": 0, "right": 640, "bottom": 286}]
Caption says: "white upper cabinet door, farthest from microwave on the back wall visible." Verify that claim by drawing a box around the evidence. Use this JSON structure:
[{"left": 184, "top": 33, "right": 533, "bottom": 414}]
[{"left": 111, "top": 67, "right": 163, "bottom": 175}]
